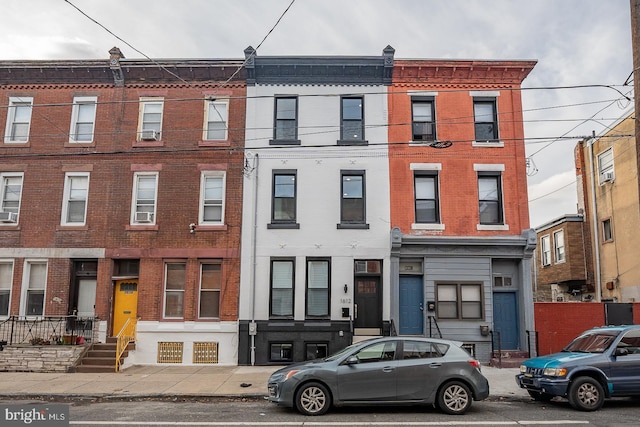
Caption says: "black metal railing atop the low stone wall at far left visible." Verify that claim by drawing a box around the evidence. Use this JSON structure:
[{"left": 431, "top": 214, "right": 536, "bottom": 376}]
[{"left": 0, "top": 316, "right": 99, "bottom": 345}]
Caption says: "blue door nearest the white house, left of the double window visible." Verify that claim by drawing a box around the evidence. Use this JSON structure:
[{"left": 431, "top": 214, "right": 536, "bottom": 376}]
[{"left": 399, "top": 276, "right": 424, "bottom": 335}]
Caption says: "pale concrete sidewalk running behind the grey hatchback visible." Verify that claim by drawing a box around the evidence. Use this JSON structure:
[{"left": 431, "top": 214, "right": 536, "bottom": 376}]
[{"left": 0, "top": 366, "right": 528, "bottom": 399}]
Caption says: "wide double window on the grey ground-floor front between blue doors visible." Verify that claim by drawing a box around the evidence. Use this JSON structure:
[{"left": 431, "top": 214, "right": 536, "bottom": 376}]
[{"left": 436, "top": 283, "right": 483, "bottom": 320}]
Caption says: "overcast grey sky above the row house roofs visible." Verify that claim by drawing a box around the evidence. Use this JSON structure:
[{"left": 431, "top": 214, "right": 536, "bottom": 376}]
[{"left": 0, "top": 0, "right": 633, "bottom": 227}]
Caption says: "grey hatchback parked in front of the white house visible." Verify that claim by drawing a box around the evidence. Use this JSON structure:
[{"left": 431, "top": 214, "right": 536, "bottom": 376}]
[{"left": 268, "top": 337, "right": 489, "bottom": 415}]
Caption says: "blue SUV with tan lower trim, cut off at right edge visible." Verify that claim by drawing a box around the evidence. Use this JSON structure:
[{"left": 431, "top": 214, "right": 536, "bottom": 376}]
[{"left": 516, "top": 325, "right": 640, "bottom": 411}]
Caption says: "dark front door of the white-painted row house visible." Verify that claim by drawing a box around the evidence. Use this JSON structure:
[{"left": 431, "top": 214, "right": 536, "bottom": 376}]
[{"left": 353, "top": 277, "right": 382, "bottom": 335}]
